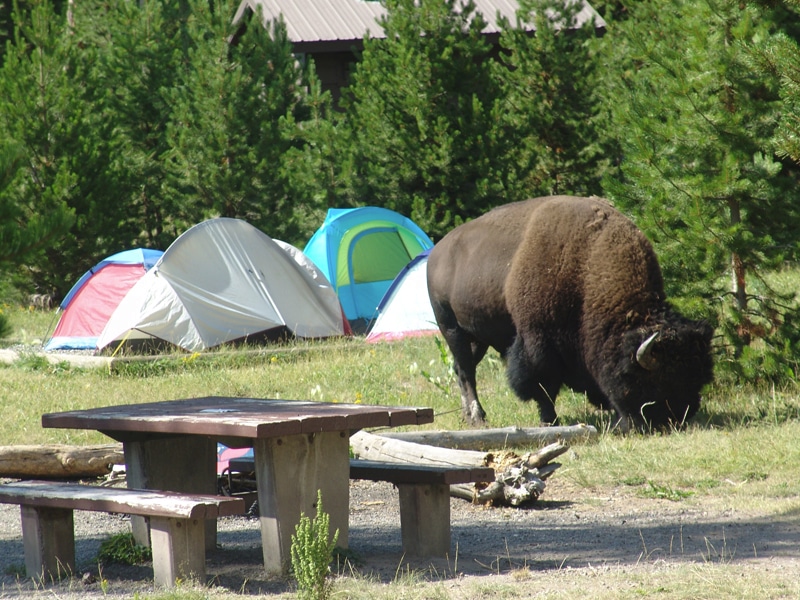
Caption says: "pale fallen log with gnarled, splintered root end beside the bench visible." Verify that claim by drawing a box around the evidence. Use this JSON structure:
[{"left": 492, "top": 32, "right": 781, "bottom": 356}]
[{"left": 350, "top": 431, "right": 569, "bottom": 506}]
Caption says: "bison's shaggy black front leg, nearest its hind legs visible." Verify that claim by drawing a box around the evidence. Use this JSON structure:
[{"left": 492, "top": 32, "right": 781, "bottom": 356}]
[{"left": 507, "top": 335, "right": 562, "bottom": 425}]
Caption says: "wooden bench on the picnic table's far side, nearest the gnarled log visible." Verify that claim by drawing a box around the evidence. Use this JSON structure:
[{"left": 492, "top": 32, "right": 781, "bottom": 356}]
[{"left": 229, "top": 457, "right": 495, "bottom": 557}]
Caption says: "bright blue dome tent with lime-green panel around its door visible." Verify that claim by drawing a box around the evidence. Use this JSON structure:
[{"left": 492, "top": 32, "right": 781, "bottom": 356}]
[{"left": 303, "top": 206, "right": 433, "bottom": 329}]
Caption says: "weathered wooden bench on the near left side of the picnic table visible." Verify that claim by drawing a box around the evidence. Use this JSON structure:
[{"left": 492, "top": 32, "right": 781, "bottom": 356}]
[{"left": 0, "top": 481, "right": 245, "bottom": 587}]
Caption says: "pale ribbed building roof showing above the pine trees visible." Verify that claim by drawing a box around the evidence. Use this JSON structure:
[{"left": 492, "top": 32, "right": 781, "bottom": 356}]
[{"left": 234, "top": 0, "right": 605, "bottom": 48}]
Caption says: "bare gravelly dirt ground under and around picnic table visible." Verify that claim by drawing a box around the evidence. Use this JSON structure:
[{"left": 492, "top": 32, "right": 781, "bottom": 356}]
[{"left": 0, "top": 474, "right": 800, "bottom": 600}]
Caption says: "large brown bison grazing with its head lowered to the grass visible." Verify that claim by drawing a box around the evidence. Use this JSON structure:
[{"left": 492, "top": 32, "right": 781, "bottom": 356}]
[{"left": 428, "top": 196, "right": 713, "bottom": 431}]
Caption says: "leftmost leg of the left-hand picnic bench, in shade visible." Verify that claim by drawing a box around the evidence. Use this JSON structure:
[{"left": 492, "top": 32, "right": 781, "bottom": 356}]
[{"left": 21, "top": 506, "right": 75, "bottom": 581}]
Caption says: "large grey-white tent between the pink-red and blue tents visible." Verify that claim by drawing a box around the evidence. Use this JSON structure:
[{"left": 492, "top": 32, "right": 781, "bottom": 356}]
[{"left": 97, "top": 218, "right": 349, "bottom": 352}]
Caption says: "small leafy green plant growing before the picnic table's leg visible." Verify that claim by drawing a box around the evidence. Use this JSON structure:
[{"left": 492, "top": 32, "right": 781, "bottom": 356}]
[{"left": 291, "top": 490, "right": 339, "bottom": 600}]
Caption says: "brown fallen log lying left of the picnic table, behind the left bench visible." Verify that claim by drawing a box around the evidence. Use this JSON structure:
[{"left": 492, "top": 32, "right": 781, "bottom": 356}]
[{"left": 0, "top": 444, "right": 125, "bottom": 479}]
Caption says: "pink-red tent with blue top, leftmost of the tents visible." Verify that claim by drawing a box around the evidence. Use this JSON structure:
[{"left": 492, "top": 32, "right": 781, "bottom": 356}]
[{"left": 44, "top": 248, "right": 163, "bottom": 351}]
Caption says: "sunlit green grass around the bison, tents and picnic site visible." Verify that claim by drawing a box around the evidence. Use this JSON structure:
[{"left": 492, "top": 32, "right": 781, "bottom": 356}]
[{"left": 0, "top": 308, "right": 800, "bottom": 600}]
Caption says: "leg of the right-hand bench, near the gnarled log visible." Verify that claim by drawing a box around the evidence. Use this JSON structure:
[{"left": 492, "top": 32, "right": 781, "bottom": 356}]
[{"left": 397, "top": 484, "right": 450, "bottom": 557}]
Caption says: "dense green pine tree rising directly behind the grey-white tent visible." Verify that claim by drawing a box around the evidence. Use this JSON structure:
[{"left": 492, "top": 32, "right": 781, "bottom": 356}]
[{"left": 169, "top": 0, "right": 314, "bottom": 240}]
